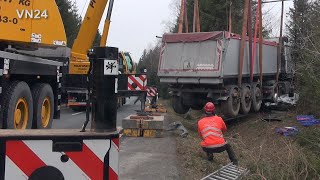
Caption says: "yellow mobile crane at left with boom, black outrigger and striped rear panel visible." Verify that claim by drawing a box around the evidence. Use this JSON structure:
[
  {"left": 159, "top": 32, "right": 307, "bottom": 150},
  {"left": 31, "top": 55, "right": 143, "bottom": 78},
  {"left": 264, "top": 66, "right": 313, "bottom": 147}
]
[{"left": 0, "top": 0, "right": 120, "bottom": 180}]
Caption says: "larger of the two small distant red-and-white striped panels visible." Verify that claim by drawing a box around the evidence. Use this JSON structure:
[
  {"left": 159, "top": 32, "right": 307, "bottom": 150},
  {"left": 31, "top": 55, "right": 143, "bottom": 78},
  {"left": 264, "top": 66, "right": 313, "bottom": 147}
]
[{"left": 128, "top": 75, "right": 147, "bottom": 91}]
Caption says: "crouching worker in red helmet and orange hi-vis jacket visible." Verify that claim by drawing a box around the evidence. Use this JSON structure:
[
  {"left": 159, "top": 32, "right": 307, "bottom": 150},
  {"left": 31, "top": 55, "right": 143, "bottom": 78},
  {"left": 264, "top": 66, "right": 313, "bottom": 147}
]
[{"left": 198, "top": 102, "right": 238, "bottom": 165}]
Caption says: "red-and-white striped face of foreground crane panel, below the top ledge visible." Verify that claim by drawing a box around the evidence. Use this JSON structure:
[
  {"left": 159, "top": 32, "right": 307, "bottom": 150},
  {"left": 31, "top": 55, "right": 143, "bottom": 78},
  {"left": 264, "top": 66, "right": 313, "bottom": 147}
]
[{"left": 5, "top": 139, "right": 119, "bottom": 180}]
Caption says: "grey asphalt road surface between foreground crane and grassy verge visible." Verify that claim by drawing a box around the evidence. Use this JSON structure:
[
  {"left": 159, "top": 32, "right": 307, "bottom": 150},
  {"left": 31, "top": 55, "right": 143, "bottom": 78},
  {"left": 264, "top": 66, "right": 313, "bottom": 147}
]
[{"left": 53, "top": 97, "right": 179, "bottom": 180}]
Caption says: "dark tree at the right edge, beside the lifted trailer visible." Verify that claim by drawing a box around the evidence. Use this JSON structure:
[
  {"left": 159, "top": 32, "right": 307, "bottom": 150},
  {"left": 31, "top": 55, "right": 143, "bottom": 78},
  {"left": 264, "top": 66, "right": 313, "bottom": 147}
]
[{"left": 288, "top": 0, "right": 320, "bottom": 114}]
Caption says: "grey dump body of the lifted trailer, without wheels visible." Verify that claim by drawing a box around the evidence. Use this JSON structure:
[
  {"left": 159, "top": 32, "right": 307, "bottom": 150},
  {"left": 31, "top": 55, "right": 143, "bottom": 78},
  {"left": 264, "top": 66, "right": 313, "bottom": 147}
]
[{"left": 158, "top": 31, "right": 292, "bottom": 84}]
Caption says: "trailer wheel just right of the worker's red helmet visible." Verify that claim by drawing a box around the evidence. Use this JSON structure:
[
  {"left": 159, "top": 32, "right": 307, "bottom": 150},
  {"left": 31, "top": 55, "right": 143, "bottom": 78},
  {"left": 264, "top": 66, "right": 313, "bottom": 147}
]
[{"left": 221, "top": 87, "right": 240, "bottom": 118}]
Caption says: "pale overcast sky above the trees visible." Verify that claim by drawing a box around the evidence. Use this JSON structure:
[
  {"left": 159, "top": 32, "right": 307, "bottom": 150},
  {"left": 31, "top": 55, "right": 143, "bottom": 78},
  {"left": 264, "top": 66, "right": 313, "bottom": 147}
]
[{"left": 74, "top": 0, "right": 292, "bottom": 62}]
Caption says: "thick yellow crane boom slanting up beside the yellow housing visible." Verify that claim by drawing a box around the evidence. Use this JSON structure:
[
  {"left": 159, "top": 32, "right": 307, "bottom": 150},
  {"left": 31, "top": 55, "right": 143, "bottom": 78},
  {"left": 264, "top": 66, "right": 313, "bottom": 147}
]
[{"left": 69, "top": 0, "right": 108, "bottom": 74}]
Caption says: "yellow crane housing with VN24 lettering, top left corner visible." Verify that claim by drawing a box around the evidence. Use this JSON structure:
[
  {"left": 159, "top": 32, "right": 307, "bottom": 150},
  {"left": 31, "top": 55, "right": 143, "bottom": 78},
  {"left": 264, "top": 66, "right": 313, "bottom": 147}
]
[{"left": 0, "top": 0, "right": 67, "bottom": 47}]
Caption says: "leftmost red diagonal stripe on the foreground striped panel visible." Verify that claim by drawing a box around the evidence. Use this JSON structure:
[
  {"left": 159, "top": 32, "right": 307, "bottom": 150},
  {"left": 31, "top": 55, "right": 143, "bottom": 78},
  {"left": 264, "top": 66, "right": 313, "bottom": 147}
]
[{"left": 6, "top": 141, "right": 46, "bottom": 177}]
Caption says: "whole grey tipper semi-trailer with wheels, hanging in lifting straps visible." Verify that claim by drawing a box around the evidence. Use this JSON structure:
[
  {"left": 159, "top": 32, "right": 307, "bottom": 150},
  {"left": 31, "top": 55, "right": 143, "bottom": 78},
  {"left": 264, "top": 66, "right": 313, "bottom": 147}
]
[{"left": 158, "top": 31, "right": 294, "bottom": 117}]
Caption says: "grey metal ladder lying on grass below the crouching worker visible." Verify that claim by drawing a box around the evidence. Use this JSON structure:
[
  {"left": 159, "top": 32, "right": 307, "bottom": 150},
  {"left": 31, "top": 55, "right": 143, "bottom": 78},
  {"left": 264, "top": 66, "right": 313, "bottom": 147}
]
[{"left": 201, "top": 163, "right": 249, "bottom": 180}]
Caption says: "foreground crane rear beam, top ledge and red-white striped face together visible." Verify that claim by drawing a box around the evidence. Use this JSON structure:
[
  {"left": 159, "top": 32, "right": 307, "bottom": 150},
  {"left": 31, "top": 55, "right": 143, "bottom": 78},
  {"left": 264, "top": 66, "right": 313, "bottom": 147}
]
[{"left": 0, "top": 130, "right": 119, "bottom": 180}]
